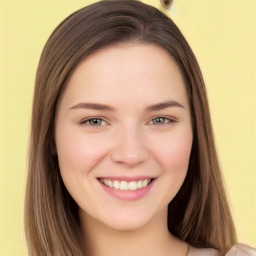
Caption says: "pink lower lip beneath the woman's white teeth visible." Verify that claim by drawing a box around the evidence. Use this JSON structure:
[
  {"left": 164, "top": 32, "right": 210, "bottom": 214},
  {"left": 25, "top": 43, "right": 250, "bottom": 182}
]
[{"left": 99, "top": 179, "right": 156, "bottom": 201}]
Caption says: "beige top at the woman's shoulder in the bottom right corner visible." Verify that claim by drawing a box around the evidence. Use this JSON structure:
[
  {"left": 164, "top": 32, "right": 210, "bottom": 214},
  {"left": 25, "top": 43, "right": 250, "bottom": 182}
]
[{"left": 188, "top": 244, "right": 256, "bottom": 256}]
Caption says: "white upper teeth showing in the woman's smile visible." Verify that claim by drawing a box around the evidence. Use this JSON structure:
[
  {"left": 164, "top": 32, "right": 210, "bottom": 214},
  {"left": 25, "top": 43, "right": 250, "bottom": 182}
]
[{"left": 100, "top": 179, "right": 151, "bottom": 191}]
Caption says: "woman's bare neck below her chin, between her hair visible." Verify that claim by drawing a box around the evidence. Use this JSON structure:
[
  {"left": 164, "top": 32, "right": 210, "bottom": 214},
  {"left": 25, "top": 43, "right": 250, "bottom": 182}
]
[{"left": 80, "top": 210, "right": 188, "bottom": 256}]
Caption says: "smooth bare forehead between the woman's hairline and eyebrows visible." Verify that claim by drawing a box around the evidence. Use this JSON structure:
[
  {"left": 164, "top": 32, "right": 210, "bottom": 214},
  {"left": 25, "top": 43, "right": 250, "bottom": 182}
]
[{"left": 58, "top": 43, "right": 187, "bottom": 110}]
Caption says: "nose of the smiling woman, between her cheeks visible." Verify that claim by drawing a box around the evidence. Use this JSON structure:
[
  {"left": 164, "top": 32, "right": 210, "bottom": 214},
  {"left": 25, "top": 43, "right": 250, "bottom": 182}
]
[{"left": 110, "top": 127, "right": 149, "bottom": 167}]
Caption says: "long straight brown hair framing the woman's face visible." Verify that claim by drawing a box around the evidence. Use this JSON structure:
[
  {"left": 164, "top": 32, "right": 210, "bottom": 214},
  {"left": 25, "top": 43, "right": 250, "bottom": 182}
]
[{"left": 25, "top": 0, "right": 236, "bottom": 256}]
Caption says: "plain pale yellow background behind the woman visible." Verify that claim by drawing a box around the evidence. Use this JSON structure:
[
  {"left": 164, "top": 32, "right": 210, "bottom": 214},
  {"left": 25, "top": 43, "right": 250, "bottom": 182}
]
[{"left": 0, "top": 0, "right": 256, "bottom": 256}]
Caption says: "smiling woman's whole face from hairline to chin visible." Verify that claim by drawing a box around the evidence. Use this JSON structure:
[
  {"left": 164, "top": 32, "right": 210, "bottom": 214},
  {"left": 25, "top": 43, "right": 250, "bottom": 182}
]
[{"left": 55, "top": 44, "right": 193, "bottom": 230}]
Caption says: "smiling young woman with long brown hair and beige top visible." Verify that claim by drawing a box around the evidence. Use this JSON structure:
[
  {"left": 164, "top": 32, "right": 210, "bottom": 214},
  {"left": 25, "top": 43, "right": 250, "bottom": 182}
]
[{"left": 25, "top": 0, "right": 256, "bottom": 256}]
